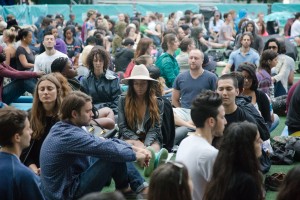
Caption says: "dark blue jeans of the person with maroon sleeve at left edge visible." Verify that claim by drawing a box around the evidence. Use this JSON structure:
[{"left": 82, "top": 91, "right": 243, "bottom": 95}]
[{"left": 2, "top": 78, "right": 37, "bottom": 104}]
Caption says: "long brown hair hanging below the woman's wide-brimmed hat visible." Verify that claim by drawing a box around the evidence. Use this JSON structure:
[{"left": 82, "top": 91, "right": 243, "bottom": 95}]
[{"left": 125, "top": 80, "right": 159, "bottom": 129}]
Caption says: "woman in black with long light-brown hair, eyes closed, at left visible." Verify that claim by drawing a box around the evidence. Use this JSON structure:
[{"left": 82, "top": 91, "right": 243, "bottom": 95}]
[{"left": 21, "top": 74, "right": 66, "bottom": 175}]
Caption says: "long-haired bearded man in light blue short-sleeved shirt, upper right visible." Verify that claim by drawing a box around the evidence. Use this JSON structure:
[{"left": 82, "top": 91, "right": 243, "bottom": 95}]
[{"left": 222, "top": 32, "right": 260, "bottom": 74}]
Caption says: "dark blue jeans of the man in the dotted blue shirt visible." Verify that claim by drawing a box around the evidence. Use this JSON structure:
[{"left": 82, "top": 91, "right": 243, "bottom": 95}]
[{"left": 74, "top": 158, "right": 147, "bottom": 199}]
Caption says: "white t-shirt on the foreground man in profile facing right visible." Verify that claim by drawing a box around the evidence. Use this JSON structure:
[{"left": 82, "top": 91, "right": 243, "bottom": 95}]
[{"left": 176, "top": 135, "right": 219, "bottom": 200}]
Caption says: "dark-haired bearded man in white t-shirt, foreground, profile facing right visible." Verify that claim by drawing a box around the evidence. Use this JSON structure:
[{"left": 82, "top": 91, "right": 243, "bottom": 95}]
[{"left": 176, "top": 91, "right": 227, "bottom": 199}]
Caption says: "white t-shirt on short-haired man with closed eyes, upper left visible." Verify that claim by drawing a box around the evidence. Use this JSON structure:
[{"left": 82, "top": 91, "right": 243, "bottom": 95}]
[{"left": 33, "top": 50, "right": 68, "bottom": 74}]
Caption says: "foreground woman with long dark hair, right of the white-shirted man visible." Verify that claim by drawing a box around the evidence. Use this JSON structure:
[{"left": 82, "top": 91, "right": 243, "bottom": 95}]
[{"left": 203, "top": 121, "right": 264, "bottom": 200}]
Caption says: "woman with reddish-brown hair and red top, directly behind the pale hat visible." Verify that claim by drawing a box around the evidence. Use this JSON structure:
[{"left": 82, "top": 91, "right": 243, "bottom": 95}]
[{"left": 123, "top": 38, "right": 153, "bottom": 78}]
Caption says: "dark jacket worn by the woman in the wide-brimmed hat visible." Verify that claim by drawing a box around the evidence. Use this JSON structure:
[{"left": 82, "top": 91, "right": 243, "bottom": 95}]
[{"left": 118, "top": 96, "right": 164, "bottom": 146}]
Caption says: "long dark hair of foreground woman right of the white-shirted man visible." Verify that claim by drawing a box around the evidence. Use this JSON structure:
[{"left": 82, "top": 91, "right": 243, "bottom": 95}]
[{"left": 203, "top": 121, "right": 263, "bottom": 200}]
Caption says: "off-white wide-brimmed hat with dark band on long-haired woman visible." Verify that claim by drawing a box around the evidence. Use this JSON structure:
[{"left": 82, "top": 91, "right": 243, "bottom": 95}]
[{"left": 122, "top": 64, "right": 157, "bottom": 84}]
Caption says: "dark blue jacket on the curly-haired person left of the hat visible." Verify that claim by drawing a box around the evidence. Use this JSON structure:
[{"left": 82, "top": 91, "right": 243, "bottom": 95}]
[{"left": 81, "top": 70, "right": 121, "bottom": 115}]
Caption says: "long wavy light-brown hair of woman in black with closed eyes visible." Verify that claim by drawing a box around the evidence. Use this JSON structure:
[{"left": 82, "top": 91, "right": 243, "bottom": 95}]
[{"left": 30, "top": 74, "right": 62, "bottom": 139}]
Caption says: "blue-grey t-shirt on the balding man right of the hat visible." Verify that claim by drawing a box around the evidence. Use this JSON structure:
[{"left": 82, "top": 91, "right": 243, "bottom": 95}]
[{"left": 173, "top": 70, "right": 217, "bottom": 108}]
